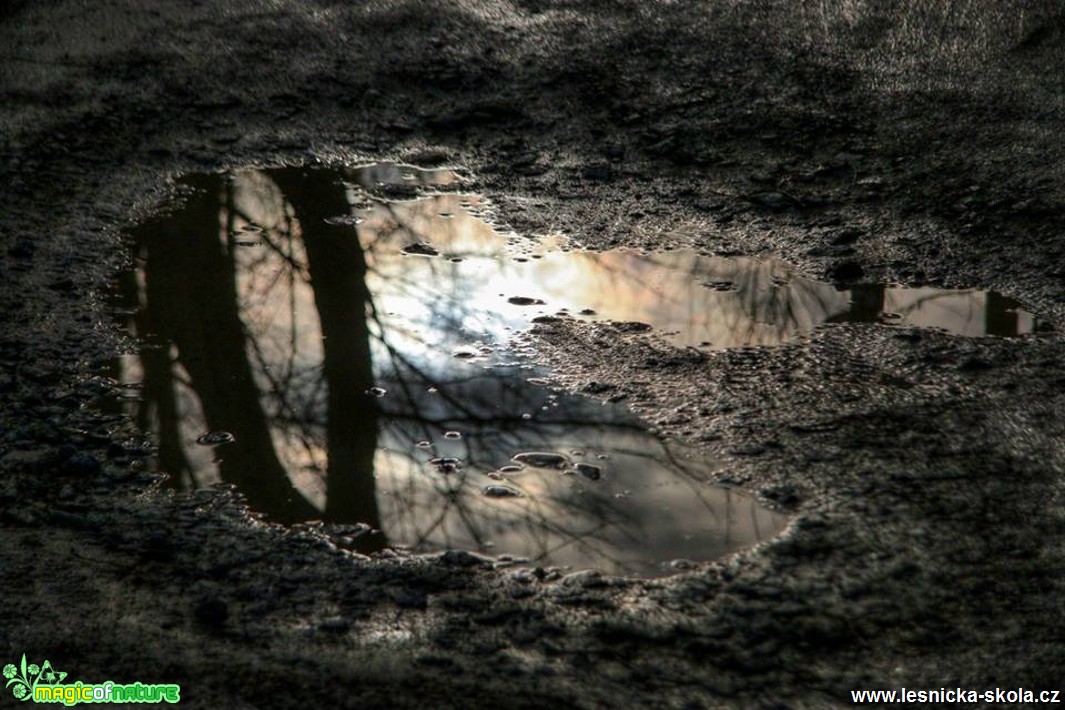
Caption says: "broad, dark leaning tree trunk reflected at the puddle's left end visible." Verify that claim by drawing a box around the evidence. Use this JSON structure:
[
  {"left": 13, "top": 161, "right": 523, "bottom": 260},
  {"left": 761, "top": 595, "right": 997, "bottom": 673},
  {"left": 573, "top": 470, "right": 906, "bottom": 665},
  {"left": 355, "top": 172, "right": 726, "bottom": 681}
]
[{"left": 125, "top": 176, "right": 313, "bottom": 519}]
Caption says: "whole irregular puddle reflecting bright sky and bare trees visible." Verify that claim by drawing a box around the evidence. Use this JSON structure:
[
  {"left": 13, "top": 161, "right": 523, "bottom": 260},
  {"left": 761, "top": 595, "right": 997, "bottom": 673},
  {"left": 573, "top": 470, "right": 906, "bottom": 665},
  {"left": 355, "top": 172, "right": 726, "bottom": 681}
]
[{"left": 105, "top": 164, "right": 1037, "bottom": 576}]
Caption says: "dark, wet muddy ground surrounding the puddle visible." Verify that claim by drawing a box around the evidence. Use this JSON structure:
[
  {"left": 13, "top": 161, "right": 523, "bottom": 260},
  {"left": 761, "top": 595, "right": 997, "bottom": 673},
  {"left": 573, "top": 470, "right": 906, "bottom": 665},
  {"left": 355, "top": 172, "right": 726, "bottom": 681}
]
[{"left": 0, "top": 0, "right": 1065, "bottom": 709}]
